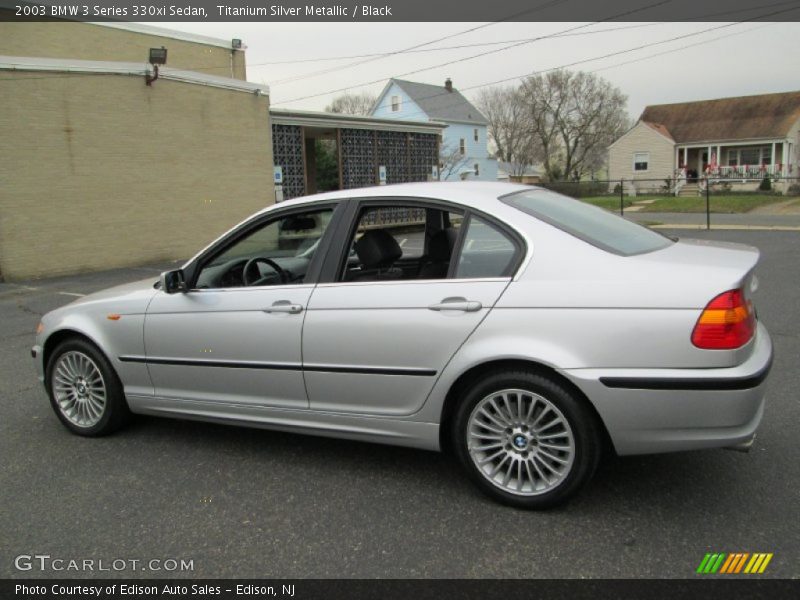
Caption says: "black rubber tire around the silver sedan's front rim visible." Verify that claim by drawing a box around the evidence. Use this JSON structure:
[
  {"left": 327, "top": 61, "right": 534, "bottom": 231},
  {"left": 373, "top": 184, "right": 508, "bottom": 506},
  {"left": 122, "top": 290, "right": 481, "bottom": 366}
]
[{"left": 45, "top": 337, "right": 132, "bottom": 437}]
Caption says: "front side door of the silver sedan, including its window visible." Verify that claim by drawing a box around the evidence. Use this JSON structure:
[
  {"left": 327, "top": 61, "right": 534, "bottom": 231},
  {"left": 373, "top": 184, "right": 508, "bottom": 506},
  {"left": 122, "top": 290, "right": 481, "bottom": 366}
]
[{"left": 145, "top": 208, "right": 333, "bottom": 408}]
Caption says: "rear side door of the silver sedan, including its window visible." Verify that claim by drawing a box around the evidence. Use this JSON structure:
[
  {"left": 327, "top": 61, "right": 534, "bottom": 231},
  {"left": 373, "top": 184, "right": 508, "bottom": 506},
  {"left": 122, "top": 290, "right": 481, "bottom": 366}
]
[{"left": 303, "top": 200, "right": 523, "bottom": 415}]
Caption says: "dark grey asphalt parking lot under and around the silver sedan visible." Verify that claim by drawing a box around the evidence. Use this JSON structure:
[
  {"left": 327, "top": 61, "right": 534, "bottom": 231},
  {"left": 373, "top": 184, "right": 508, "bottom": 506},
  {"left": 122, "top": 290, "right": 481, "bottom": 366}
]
[{"left": 0, "top": 231, "right": 800, "bottom": 578}]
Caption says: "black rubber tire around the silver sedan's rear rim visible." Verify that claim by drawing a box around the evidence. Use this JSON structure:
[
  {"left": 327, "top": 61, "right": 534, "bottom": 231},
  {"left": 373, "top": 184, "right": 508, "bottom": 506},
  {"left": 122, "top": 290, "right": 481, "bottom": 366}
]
[{"left": 450, "top": 370, "right": 602, "bottom": 510}]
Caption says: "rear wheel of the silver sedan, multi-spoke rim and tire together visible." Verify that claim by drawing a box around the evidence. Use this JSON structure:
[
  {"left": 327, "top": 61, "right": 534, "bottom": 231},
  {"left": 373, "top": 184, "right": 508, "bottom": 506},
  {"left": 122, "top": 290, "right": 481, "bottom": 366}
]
[{"left": 452, "top": 371, "right": 601, "bottom": 509}]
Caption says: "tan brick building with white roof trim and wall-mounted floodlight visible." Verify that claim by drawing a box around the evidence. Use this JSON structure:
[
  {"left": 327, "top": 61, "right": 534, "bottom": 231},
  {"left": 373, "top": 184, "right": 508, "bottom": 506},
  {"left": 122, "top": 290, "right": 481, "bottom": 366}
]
[{"left": 0, "top": 22, "right": 274, "bottom": 280}]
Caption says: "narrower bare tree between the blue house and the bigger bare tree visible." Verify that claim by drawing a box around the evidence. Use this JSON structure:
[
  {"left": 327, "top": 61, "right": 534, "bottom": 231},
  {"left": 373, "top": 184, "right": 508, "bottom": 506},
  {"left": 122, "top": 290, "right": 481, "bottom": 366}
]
[{"left": 477, "top": 87, "right": 544, "bottom": 176}]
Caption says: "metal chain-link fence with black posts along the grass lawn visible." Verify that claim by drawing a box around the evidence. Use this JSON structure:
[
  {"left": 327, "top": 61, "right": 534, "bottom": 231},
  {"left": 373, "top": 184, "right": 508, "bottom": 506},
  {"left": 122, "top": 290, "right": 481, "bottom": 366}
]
[{"left": 539, "top": 174, "right": 800, "bottom": 229}]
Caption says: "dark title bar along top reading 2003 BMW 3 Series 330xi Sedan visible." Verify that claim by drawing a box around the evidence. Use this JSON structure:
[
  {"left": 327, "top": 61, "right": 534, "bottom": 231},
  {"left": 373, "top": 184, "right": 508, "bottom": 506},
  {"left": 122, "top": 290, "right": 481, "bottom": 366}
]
[{"left": 0, "top": 0, "right": 800, "bottom": 23}]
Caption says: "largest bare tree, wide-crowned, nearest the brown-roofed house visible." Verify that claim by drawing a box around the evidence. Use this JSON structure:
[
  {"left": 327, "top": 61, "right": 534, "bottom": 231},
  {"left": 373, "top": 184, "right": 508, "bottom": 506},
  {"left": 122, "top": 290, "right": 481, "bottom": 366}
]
[{"left": 521, "top": 70, "right": 630, "bottom": 180}]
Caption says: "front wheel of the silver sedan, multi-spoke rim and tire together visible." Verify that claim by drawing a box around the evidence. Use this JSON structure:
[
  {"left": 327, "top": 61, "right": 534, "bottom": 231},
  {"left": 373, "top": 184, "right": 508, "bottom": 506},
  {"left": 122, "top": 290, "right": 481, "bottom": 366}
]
[{"left": 45, "top": 338, "right": 131, "bottom": 436}]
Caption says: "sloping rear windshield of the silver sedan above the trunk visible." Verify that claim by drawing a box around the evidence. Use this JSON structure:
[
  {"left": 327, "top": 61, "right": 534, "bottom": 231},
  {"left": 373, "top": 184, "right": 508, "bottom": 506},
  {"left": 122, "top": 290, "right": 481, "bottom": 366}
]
[{"left": 500, "top": 189, "right": 673, "bottom": 256}]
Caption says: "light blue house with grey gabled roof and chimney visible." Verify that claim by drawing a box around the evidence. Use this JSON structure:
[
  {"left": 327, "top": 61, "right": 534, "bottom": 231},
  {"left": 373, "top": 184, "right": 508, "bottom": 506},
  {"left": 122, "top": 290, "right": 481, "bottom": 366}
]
[{"left": 371, "top": 78, "right": 497, "bottom": 181}]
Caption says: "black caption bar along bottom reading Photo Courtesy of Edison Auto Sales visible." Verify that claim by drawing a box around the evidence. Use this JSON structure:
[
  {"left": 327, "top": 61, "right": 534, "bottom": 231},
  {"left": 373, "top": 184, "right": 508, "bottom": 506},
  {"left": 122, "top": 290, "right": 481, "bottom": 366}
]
[{"left": 0, "top": 576, "right": 800, "bottom": 600}]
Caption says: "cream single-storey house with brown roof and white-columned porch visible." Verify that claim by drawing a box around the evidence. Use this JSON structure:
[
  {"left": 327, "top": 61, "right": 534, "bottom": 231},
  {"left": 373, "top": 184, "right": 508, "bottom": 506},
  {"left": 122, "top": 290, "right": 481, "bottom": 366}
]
[{"left": 609, "top": 92, "right": 800, "bottom": 191}]
